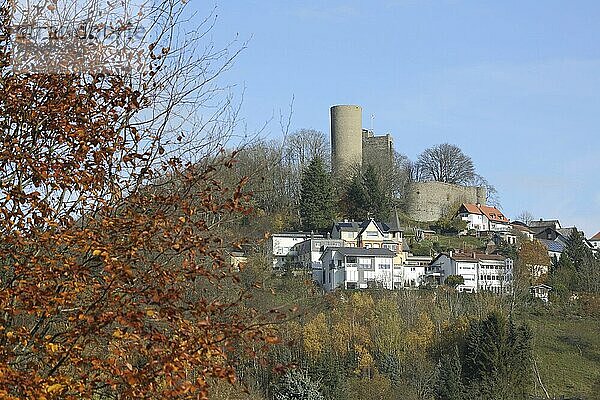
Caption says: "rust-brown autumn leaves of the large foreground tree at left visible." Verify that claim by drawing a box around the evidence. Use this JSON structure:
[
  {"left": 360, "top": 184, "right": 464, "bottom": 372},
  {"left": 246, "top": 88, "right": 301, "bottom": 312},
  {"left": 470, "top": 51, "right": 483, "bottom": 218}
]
[{"left": 0, "top": 3, "right": 277, "bottom": 399}]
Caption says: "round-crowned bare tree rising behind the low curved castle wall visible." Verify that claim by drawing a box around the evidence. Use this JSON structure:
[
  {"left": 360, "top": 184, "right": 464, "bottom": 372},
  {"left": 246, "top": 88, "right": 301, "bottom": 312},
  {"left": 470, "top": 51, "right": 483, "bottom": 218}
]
[{"left": 417, "top": 143, "right": 475, "bottom": 185}]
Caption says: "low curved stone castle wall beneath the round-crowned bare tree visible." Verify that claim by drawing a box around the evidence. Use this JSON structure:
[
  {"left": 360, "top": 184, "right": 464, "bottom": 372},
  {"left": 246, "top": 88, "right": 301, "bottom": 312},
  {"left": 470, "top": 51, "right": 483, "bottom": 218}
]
[{"left": 406, "top": 182, "right": 486, "bottom": 222}]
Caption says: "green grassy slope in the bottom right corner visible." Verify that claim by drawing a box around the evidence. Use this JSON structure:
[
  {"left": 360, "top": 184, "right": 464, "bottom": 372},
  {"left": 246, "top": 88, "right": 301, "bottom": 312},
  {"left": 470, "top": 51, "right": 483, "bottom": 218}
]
[{"left": 525, "top": 311, "right": 600, "bottom": 399}]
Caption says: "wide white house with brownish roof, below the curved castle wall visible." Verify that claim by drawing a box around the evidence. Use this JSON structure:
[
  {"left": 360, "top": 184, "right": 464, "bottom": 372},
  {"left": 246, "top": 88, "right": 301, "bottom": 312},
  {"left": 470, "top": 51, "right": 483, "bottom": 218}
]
[{"left": 426, "top": 252, "right": 513, "bottom": 293}]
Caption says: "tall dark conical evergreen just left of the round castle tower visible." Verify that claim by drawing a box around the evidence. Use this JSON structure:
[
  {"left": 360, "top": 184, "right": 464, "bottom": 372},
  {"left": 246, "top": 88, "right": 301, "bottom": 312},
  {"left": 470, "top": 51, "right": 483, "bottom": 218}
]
[{"left": 300, "top": 157, "right": 335, "bottom": 231}]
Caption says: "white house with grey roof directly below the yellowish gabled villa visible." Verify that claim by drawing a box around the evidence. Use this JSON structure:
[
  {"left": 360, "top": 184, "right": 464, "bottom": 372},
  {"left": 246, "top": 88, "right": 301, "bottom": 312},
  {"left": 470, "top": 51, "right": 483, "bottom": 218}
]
[{"left": 321, "top": 247, "right": 395, "bottom": 292}]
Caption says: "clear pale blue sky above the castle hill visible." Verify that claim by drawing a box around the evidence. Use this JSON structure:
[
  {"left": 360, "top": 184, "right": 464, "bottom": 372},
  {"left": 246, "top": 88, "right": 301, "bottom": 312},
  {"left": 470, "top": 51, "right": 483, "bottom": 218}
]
[{"left": 193, "top": 0, "right": 600, "bottom": 237}]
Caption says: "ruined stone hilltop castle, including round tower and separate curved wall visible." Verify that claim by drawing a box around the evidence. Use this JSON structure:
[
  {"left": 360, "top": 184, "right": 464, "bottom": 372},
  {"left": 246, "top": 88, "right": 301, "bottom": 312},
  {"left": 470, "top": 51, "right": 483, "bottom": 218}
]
[{"left": 330, "top": 105, "right": 486, "bottom": 222}]
